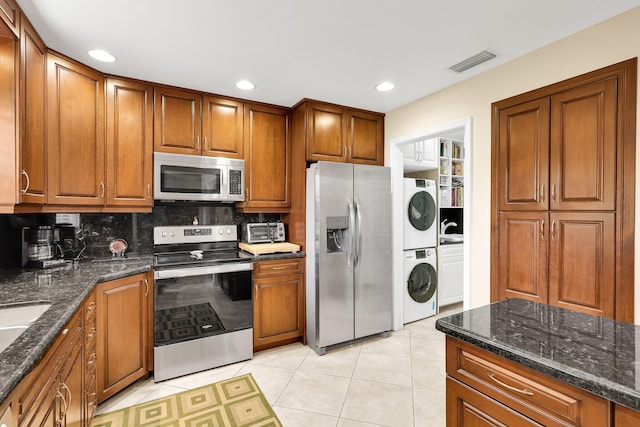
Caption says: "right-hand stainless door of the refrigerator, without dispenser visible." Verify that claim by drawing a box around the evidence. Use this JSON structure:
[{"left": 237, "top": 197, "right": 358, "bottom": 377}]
[{"left": 353, "top": 165, "right": 393, "bottom": 338}]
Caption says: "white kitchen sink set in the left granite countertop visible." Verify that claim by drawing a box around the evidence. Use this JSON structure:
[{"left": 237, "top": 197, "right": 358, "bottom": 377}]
[{"left": 0, "top": 301, "right": 51, "bottom": 352}]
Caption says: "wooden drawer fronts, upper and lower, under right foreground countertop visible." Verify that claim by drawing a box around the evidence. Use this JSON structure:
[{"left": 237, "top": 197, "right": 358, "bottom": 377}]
[{"left": 446, "top": 337, "right": 611, "bottom": 427}]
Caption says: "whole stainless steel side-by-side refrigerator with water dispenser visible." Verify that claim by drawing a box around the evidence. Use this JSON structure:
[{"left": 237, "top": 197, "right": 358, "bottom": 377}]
[{"left": 306, "top": 162, "right": 393, "bottom": 354}]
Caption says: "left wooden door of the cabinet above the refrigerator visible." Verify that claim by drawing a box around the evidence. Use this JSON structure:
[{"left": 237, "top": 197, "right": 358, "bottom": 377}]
[{"left": 307, "top": 102, "right": 347, "bottom": 162}]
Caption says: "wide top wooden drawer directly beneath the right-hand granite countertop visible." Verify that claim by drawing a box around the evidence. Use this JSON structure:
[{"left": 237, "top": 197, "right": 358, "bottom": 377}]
[{"left": 447, "top": 338, "right": 609, "bottom": 426}]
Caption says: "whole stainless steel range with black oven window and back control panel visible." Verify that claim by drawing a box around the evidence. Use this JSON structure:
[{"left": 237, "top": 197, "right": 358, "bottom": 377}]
[{"left": 153, "top": 225, "right": 253, "bottom": 382}]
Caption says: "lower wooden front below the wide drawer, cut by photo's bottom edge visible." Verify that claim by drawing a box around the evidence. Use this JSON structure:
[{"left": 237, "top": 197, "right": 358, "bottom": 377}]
[{"left": 446, "top": 377, "right": 542, "bottom": 427}]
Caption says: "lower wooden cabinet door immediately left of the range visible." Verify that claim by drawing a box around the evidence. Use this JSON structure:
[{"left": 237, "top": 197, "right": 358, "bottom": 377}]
[{"left": 96, "top": 274, "right": 151, "bottom": 402}]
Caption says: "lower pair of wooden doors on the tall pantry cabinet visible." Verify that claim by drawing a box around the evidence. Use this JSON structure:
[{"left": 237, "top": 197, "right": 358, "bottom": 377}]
[{"left": 497, "top": 211, "right": 616, "bottom": 318}]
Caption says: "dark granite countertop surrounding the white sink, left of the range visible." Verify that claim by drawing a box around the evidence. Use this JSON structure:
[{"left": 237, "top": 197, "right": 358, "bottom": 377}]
[{"left": 0, "top": 256, "right": 153, "bottom": 404}]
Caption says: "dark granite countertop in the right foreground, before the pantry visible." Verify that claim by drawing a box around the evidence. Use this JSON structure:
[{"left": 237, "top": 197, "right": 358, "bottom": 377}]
[{"left": 436, "top": 299, "right": 640, "bottom": 410}]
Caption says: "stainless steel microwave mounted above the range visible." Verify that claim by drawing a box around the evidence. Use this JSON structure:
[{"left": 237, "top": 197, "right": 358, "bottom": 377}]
[{"left": 153, "top": 153, "right": 244, "bottom": 203}]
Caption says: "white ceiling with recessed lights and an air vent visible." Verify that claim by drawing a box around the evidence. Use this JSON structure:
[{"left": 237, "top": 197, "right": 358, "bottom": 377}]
[{"left": 13, "top": 0, "right": 640, "bottom": 112}]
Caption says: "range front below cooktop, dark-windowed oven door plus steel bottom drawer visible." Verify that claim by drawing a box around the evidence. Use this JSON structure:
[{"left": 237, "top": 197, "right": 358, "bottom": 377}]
[{"left": 154, "top": 262, "right": 253, "bottom": 381}]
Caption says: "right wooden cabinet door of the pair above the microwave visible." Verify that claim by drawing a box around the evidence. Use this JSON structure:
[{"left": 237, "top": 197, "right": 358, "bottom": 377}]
[{"left": 202, "top": 96, "right": 244, "bottom": 159}]
